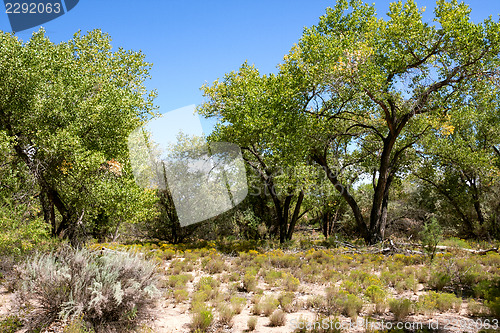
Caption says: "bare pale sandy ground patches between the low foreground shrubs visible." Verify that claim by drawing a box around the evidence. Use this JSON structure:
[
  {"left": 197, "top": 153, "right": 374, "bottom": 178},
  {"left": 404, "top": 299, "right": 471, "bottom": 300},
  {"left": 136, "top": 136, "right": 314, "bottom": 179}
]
[{"left": 0, "top": 263, "right": 492, "bottom": 333}]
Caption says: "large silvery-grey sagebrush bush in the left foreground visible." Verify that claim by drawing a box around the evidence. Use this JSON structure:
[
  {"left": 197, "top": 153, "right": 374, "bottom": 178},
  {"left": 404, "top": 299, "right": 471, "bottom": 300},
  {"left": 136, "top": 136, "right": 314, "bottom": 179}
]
[{"left": 16, "top": 246, "right": 159, "bottom": 329}]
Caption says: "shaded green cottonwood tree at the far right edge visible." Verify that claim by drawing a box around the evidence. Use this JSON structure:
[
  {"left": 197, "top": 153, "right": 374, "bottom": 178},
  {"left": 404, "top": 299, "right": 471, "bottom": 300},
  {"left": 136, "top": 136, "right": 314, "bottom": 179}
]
[{"left": 413, "top": 80, "right": 500, "bottom": 236}]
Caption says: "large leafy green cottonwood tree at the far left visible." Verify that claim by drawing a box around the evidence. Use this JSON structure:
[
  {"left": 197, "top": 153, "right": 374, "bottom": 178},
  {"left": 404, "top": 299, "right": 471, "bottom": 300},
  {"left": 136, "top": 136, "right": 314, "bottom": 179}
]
[{"left": 0, "top": 30, "right": 155, "bottom": 239}]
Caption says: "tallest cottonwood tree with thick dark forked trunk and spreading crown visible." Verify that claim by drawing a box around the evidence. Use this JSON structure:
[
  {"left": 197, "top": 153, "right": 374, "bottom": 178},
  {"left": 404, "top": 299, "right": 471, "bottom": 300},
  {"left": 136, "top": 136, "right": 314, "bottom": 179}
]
[{"left": 280, "top": 0, "right": 500, "bottom": 243}]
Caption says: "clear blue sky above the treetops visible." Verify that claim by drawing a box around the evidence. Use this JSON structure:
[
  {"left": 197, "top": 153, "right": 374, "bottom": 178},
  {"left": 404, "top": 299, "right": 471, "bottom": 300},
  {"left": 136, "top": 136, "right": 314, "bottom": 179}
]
[{"left": 0, "top": 0, "right": 500, "bottom": 136}]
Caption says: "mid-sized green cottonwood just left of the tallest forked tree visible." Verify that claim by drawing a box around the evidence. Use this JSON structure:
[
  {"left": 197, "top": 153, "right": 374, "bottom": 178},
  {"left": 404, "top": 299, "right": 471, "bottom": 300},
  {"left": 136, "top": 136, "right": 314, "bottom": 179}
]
[{"left": 197, "top": 63, "right": 307, "bottom": 242}]
